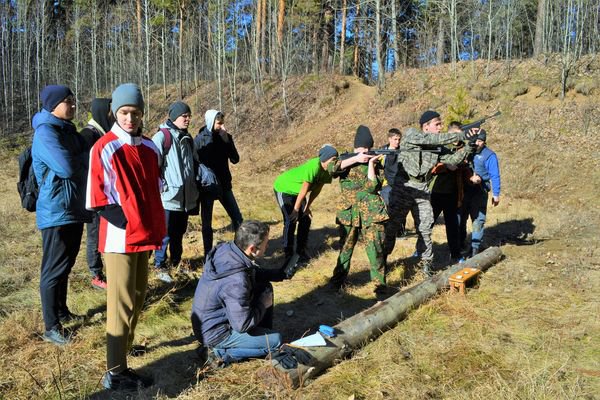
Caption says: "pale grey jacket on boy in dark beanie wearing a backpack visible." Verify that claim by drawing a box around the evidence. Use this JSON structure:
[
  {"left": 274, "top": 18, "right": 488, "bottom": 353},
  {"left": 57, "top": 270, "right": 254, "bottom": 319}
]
[{"left": 152, "top": 120, "right": 199, "bottom": 212}]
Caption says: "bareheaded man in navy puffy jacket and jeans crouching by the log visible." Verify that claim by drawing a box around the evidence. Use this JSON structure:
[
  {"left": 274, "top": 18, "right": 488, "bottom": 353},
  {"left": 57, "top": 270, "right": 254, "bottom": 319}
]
[{"left": 192, "top": 221, "right": 281, "bottom": 364}]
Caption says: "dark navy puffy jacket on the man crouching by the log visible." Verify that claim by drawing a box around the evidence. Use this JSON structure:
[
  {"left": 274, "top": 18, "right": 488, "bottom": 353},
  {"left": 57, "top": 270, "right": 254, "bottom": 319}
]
[{"left": 192, "top": 242, "right": 266, "bottom": 347}]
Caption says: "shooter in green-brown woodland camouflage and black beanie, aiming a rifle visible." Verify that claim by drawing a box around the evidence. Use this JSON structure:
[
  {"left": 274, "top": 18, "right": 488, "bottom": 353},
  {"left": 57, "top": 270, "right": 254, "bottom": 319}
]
[{"left": 328, "top": 125, "right": 388, "bottom": 291}]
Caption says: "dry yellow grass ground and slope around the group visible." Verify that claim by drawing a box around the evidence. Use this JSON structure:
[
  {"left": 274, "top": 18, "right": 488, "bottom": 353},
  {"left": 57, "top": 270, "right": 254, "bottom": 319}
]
[{"left": 0, "top": 59, "right": 600, "bottom": 400}]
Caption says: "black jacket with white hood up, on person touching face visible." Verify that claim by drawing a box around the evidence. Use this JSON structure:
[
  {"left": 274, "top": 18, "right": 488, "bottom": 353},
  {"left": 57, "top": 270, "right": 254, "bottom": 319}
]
[{"left": 194, "top": 110, "right": 240, "bottom": 190}]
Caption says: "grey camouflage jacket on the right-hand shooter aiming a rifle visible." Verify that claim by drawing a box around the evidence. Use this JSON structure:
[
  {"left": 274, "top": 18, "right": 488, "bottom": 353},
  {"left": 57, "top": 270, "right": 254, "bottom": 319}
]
[{"left": 396, "top": 128, "right": 472, "bottom": 182}]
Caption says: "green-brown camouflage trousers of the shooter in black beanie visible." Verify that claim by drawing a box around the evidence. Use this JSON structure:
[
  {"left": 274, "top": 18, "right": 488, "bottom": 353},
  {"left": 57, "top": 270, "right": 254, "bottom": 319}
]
[{"left": 331, "top": 223, "right": 385, "bottom": 285}]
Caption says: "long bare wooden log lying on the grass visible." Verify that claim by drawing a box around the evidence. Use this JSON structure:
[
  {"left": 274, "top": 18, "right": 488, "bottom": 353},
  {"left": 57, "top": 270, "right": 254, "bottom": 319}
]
[{"left": 257, "top": 247, "right": 502, "bottom": 388}]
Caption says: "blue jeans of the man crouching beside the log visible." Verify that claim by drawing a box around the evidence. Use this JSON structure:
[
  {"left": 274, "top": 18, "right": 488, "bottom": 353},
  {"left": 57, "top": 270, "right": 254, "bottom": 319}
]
[{"left": 213, "top": 326, "right": 281, "bottom": 364}]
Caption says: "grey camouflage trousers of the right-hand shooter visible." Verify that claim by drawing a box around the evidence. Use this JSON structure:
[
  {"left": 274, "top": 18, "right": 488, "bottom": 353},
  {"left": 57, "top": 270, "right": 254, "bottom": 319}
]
[{"left": 384, "top": 181, "right": 434, "bottom": 261}]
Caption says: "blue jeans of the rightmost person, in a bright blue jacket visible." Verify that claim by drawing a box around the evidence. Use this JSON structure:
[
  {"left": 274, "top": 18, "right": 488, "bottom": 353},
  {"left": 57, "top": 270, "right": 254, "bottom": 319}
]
[{"left": 460, "top": 186, "right": 488, "bottom": 254}]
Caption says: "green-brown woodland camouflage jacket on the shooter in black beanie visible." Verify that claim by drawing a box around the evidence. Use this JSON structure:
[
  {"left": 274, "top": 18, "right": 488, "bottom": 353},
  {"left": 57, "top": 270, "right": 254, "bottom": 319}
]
[{"left": 328, "top": 158, "right": 388, "bottom": 228}]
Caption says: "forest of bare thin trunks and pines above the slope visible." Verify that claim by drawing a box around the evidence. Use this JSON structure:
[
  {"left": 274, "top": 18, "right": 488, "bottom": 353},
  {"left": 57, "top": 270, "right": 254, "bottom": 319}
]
[{"left": 0, "top": 0, "right": 600, "bottom": 133}]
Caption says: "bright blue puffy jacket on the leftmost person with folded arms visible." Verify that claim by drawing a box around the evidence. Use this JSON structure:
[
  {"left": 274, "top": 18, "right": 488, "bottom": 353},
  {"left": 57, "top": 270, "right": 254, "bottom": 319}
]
[{"left": 31, "top": 110, "right": 91, "bottom": 229}]
